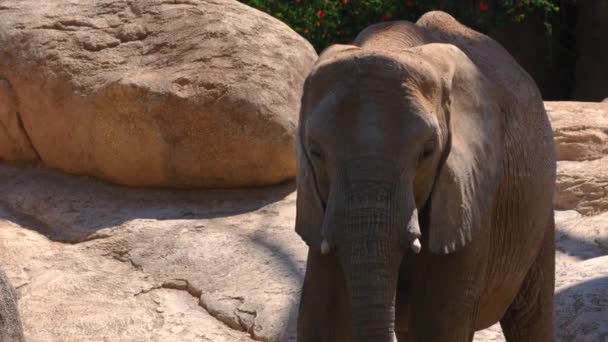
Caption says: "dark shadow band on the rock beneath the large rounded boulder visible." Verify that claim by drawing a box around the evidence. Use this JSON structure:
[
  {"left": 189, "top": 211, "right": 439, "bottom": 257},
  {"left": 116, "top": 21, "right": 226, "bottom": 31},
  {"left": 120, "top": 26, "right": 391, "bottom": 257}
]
[{"left": 0, "top": 165, "right": 295, "bottom": 243}]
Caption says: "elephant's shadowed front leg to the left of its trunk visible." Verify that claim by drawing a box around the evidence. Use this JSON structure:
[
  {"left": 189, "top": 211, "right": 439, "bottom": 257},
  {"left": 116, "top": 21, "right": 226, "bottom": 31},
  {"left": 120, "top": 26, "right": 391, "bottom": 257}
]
[{"left": 297, "top": 250, "right": 352, "bottom": 342}]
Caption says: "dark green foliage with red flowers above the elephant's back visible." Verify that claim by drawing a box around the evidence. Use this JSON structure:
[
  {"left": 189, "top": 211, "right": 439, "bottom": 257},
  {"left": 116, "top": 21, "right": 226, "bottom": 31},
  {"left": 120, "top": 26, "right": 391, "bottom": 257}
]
[{"left": 241, "top": 0, "right": 559, "bottom": 51}]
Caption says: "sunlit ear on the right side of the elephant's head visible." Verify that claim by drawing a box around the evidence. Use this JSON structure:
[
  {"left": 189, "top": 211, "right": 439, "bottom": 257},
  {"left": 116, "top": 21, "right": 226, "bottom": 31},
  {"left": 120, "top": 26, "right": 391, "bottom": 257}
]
[{"left": 422, "top": 44, "right": 502, "bottom": 254}]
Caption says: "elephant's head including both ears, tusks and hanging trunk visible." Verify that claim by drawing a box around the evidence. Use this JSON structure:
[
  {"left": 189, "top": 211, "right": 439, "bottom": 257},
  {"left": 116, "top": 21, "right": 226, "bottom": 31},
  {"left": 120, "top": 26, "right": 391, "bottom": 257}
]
[{"left": 296, "top": 44, "right": 501, "bottom": 341}]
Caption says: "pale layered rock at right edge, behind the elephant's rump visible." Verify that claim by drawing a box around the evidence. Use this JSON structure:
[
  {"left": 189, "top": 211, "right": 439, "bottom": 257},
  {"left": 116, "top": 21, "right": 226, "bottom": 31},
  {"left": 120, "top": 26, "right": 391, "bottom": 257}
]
[{"left": 545, "top": 102, "right": 608, "bottom": 215}]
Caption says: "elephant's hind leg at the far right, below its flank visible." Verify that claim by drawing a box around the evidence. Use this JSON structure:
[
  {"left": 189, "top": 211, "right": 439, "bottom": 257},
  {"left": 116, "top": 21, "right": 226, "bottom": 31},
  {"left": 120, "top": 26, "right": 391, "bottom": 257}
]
[{"left": 500, "top": 219, "right": 555, "bottom": 342}]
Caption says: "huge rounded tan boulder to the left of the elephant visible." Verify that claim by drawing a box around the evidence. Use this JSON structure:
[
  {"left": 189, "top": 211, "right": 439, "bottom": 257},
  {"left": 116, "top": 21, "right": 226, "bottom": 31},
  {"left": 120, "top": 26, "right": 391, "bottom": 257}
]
[{"left": 0, "top": 0, "right": 316, "bottom": 187}]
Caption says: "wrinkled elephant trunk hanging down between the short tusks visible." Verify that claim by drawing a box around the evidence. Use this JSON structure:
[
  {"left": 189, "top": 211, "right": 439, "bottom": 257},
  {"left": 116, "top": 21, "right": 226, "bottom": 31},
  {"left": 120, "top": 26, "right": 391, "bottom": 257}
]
[{"left": 338, "top": 178, "right": 406, "bottom": 342}]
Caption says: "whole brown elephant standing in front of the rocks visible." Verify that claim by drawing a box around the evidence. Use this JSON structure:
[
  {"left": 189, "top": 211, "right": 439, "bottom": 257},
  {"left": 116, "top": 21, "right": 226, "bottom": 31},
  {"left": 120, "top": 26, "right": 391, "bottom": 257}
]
[{"left": 295, "top": 11, "right": 556, "bottom": 342}]
